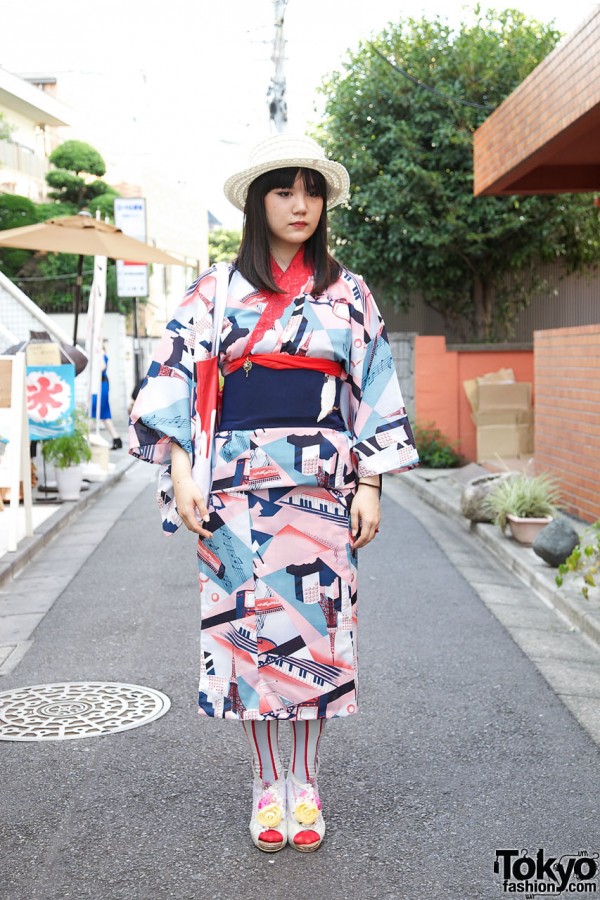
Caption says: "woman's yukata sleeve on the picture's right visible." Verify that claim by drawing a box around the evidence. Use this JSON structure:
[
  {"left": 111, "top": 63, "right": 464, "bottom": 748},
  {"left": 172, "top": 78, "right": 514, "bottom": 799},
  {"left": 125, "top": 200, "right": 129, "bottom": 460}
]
[{"left": 348, "top": 279, "right": 419, "bottom": 478}]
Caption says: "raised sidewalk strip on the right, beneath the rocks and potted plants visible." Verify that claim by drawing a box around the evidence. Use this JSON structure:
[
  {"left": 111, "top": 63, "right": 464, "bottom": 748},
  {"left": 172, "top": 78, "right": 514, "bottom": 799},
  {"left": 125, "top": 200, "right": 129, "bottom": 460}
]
[{"left": 401, "top": 465, "right": 600, "bottom": 648}]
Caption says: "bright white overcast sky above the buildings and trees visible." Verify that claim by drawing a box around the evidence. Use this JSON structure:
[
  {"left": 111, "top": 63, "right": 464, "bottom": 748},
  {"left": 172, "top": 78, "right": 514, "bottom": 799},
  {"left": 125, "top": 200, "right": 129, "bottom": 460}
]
[{"left": 0, "top": 0, "right": 597, "bottom": 227}]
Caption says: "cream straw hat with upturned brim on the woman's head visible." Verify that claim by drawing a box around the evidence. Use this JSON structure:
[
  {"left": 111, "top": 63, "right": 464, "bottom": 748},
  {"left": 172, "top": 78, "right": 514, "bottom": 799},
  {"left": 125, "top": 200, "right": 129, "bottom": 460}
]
[{"left": 223, "top": 132, "right": 350, "bottom": 212}]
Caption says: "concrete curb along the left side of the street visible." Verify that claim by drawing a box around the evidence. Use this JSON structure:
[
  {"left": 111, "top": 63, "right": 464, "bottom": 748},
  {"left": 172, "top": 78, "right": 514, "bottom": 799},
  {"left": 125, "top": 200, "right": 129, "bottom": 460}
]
[{"left": 0, "top": 457, "right": 135, "bottom": 589}]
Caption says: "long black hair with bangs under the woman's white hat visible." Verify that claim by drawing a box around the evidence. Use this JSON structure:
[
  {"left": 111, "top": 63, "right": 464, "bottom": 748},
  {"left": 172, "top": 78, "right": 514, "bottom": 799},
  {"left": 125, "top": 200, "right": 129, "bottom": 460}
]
[{"left": 235, "top": 166, "right": 342, "bottom": 294}]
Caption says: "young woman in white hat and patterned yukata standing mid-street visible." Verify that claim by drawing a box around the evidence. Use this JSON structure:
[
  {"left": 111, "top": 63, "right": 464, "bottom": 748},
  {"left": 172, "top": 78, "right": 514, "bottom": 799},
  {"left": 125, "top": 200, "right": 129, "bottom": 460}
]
[{"left": 130, "top": 134, "right": 417, "bottom": 852}]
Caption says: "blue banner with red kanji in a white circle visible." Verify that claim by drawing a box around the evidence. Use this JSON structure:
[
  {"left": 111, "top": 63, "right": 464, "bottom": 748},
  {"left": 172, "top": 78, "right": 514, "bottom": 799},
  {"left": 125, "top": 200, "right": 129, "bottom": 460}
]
[{"left": 26, "top": 364, "right": 75, "bottom": 441}]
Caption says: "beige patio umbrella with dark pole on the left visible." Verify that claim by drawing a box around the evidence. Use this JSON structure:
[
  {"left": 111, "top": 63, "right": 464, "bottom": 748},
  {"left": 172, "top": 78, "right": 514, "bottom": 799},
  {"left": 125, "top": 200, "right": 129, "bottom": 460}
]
[{"left": 0, "top": 213, "right": 185, "bottom": 344}]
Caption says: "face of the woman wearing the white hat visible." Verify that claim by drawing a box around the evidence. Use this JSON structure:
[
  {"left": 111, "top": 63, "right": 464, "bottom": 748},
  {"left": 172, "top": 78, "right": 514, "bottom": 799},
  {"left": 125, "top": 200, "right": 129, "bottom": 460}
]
[{"left": 265, "top": 173, "right": 323, "bottom": 256}]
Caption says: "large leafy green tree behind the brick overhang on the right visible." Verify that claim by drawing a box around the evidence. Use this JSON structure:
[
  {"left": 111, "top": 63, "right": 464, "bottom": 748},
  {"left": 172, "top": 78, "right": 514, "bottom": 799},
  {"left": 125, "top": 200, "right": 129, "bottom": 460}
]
[{"left": 318, "top": 8, "right": 600, "bottom": 340}]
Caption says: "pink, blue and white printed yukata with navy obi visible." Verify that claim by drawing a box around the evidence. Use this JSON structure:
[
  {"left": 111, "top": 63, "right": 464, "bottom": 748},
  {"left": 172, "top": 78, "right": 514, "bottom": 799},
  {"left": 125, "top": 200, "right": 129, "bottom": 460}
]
[{"left": 130, "top": 251, "right": 418, "bottom": 719}]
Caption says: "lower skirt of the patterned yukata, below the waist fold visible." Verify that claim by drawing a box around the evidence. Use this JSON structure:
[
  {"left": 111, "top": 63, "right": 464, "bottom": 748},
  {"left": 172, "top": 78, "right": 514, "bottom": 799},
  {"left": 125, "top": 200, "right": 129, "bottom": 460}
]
[{"left": 198, "top": 488, "right": 357, "bottom": 719}]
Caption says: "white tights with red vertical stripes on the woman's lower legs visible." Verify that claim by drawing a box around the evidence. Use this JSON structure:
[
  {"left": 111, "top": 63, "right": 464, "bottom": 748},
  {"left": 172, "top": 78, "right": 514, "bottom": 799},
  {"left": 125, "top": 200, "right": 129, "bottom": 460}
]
[{"left": 242, "top": 719, "right": 325, "bottom": 785}]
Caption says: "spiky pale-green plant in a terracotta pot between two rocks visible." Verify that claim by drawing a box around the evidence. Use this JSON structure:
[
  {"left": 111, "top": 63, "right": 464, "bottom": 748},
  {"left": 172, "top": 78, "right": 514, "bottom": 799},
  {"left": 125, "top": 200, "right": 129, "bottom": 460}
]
[{"left": 488, "top": 474, "right": 560, "bottom": 545}]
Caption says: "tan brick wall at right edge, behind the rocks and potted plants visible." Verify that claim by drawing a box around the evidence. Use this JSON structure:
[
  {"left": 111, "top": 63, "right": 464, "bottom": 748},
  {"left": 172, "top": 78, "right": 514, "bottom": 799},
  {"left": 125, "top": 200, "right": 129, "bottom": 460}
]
[{"left": 534, "top": 325, "right": 600, "bottom": 522}]
